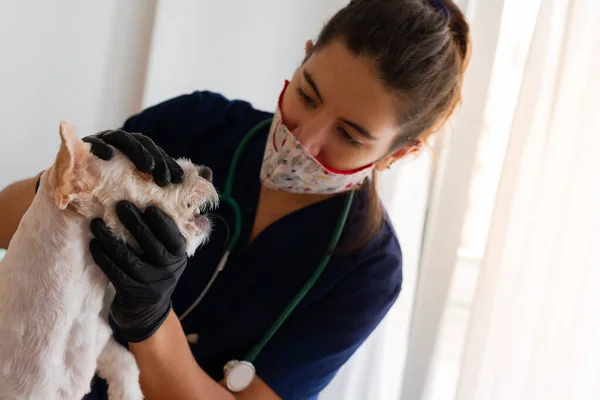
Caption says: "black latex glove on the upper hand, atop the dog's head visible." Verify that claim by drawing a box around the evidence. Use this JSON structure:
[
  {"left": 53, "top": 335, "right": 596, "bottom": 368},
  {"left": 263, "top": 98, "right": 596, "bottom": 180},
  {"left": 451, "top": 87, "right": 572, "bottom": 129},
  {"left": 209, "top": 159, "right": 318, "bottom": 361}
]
[{"left": 82, "top": 130, "right": 183, "bottom": 186}]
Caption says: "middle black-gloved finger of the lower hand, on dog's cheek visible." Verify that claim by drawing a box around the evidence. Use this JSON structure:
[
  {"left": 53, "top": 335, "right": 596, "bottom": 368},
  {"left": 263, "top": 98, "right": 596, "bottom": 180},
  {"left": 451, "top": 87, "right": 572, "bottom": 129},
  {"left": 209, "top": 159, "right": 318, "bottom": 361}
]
[{"left": 117, "top": 200, "right": 169, "bottom": 263}]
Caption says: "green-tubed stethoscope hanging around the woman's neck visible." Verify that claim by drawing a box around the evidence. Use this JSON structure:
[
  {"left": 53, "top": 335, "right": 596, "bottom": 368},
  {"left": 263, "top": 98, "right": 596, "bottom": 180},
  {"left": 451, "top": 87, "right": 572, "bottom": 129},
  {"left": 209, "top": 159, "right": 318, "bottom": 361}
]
[{"left": 179, "top": 118, "right": 354, "bottom": 392}]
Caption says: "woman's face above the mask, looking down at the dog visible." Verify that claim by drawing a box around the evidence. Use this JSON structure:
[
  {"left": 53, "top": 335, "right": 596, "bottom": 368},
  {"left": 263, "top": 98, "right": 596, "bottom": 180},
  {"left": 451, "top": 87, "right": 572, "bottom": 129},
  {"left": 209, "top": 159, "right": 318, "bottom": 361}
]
[{"left": 281, "top": 42, "right": 406, "bottom": 171}]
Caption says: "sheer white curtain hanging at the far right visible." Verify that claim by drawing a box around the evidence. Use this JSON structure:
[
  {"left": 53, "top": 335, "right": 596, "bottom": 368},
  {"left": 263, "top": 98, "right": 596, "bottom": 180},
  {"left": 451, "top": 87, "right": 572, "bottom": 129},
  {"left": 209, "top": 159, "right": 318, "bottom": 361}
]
[{"left": 456, "top": 0, "right": 600, "bottom": 400}]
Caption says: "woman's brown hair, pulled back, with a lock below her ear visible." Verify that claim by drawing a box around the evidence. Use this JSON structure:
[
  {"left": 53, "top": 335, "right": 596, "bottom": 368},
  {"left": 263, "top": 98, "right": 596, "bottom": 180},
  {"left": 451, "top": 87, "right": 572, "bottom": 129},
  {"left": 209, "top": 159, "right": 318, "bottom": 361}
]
[{"left": 313, "top": 0, "right": 471, "bottom": 253}]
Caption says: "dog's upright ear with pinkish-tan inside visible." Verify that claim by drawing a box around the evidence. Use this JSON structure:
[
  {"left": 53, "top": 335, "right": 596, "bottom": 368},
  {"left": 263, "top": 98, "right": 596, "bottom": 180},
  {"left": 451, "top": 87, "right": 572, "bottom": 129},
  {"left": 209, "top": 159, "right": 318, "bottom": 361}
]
[{"left": 52, "top": 121, "right": 92, "bottom": 210}]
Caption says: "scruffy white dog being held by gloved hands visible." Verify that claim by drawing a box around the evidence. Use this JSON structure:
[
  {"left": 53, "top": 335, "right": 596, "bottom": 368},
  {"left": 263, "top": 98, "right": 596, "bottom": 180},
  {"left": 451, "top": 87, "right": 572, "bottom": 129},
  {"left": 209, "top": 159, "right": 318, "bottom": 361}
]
[{"left": 0, "top": 122, "right": 217, "bottom": 400}]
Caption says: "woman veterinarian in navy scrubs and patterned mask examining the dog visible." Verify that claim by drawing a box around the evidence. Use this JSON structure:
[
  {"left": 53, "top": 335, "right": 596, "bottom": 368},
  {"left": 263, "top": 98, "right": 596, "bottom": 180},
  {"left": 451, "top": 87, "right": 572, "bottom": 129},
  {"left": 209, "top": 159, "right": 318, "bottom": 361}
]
[{"left": 0, "top": 0, "right": 470, "bottom": 400}]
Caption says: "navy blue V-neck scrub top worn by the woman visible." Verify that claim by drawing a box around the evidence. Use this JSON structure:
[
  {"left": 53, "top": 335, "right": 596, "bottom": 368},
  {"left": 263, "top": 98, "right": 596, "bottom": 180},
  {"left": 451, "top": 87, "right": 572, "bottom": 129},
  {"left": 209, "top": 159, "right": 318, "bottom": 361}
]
[{"left": 86, "top": 91, "right": 402, "bottom": 400}]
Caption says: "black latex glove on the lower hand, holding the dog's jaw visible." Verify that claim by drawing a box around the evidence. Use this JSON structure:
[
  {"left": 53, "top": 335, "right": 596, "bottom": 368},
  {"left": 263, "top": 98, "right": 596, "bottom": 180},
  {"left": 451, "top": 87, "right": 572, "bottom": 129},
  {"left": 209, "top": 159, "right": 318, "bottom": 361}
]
[{"left": 90, "top": 201, "right": 187, "bottom": 342}]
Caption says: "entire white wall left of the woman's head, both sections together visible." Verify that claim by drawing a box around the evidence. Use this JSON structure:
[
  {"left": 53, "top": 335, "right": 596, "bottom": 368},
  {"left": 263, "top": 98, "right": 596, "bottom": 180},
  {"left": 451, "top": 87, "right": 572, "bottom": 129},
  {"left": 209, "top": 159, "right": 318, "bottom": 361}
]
[{"left": 0, "top": 0, "right": 347, "bottom": 184}]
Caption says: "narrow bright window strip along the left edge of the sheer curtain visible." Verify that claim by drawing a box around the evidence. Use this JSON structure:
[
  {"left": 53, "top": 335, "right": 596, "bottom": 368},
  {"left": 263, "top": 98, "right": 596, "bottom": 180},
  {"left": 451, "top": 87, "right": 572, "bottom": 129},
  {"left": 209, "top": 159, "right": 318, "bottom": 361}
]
[{"left": 424, "top": 0, "right": 539, "bottom": 400}]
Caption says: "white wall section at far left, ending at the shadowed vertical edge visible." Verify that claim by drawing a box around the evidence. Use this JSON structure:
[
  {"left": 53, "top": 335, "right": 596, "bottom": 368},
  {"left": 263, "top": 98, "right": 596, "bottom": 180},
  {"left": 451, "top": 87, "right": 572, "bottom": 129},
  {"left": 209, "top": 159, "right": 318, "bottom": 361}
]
[{"left": 0, "top": 0, "right": 155, "bottom": 188}]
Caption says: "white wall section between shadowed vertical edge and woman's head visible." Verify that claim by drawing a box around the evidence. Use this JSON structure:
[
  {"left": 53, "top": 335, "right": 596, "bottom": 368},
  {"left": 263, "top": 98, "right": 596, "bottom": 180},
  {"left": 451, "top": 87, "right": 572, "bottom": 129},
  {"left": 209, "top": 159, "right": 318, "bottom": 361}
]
[{"left": 144, "top": 0, "right": 348, "bottom": 110}]
